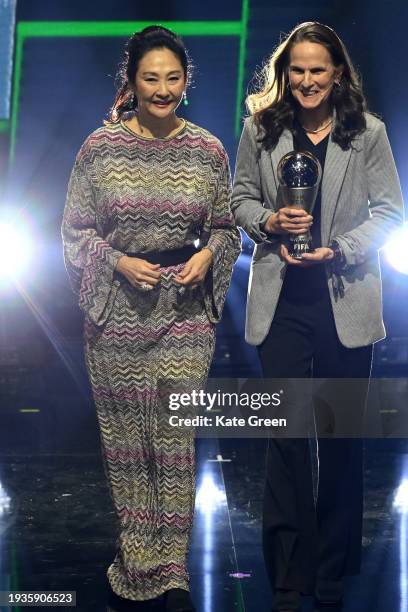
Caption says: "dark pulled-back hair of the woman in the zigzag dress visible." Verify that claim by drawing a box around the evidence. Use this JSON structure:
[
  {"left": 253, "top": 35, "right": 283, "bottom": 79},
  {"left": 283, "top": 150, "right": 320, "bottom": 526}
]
[{"left": 106, "top": 25, "right": 193, "bottom": 123}]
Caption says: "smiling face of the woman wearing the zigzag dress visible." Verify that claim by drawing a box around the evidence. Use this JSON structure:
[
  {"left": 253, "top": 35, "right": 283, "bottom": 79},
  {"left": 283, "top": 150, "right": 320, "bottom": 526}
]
[{"left": 135, "top": 48, "right": 186, "bottom": 121}]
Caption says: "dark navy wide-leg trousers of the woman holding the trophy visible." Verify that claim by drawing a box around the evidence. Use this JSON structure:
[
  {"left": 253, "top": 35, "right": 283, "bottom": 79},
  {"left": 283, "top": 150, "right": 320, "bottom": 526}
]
[{"left": 258, "top": 289, "right": 372, "bottom": 594}]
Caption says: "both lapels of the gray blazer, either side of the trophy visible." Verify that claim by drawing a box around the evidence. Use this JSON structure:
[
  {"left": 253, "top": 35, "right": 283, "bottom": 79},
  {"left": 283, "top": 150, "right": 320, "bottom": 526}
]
[{"left": 271, "top": 111, "right": 352, "bottom": 244}]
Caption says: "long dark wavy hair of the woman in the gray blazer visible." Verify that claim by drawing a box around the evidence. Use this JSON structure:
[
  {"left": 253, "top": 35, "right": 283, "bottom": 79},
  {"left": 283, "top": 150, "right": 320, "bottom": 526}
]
[{"left": 246, "top": 21, "right": 366, "bottom": 149}]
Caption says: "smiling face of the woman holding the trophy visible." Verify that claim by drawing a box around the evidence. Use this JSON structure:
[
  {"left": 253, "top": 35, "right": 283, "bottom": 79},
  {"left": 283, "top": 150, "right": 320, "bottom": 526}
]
[{"left": 289, "top": 41, "right": 342, "bottom": 111}]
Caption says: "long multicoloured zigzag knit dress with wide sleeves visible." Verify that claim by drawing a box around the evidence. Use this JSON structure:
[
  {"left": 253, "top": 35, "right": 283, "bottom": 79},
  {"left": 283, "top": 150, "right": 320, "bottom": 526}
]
[{"left": 62, "top": 122, "right": 240, "bottom": 600}]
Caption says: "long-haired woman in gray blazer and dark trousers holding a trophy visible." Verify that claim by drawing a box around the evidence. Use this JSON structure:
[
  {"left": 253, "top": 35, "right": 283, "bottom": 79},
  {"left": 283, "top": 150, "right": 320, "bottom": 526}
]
[{"left": 232, "top": 22, "right": 403, "bottom": 611}]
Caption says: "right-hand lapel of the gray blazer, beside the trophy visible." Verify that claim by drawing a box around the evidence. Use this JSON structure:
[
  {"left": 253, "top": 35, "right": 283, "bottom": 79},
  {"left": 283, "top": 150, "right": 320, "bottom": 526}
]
[{"left": 321, "top": 136, "right": 351, "bottom": 245}]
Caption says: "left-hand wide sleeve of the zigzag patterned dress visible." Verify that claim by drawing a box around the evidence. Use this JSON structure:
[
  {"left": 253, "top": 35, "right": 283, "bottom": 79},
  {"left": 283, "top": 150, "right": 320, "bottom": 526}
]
[{"left": 62, "top": 144, "right": 123, "bottom": 325}]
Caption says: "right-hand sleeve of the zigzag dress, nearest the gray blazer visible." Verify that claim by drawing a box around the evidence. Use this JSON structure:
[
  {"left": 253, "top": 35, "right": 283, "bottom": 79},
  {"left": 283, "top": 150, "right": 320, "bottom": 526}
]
[{"left": 201, "top": 150, "right": 241, "bottom": 323}]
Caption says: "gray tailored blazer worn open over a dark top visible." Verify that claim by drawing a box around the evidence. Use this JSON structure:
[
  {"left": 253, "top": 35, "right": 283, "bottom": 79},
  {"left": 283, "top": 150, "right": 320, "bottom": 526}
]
[{"left": 232, "top": 114, "right": 403, "bottom": 348}]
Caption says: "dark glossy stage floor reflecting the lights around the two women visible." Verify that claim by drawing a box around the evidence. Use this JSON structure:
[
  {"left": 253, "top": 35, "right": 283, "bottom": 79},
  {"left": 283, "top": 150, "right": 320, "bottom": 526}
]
[{"left": 0, "top": 432, "right": 408, "bottom": 612}]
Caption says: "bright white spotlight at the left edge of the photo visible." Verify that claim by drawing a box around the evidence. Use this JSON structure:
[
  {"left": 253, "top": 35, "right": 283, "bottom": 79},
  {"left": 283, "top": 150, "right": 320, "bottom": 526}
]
[{"left": 0, "top": 222, "right": 30, "bottom": 279}]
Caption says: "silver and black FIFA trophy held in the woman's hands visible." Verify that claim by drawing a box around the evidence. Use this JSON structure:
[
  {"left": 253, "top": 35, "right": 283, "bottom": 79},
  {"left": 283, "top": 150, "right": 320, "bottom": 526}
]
[{"left": 278, "top": 151, "right": 322, "bottom": 259}]
